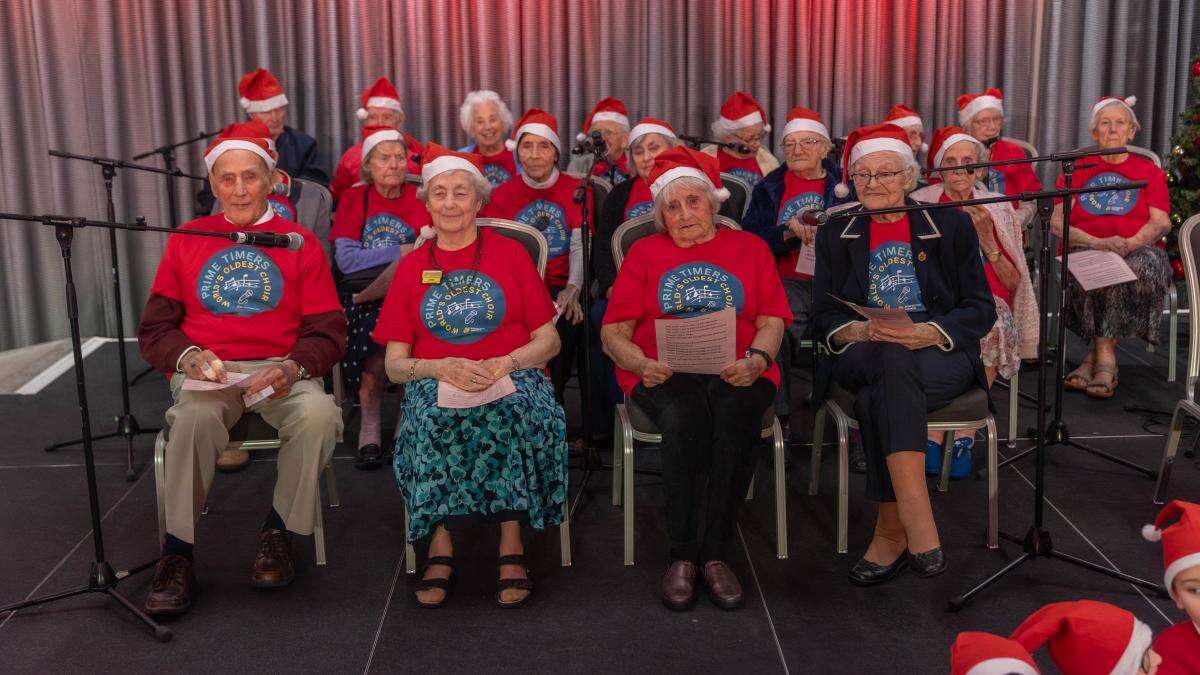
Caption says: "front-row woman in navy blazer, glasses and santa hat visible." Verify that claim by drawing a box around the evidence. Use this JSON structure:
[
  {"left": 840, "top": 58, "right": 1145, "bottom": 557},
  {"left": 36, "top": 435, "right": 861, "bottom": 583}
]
[{"left": 812, "top": 124, "right": 996, "bottom": 586}]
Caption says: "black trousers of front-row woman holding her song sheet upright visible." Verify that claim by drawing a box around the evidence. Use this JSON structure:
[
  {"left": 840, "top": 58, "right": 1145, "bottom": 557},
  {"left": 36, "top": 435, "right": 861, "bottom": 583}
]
[{"left": 631, "top": 374, "right": 775, "bottom": 562}]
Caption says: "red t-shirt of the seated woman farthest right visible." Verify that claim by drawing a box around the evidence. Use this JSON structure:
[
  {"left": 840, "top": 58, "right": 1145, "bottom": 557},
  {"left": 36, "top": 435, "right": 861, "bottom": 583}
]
[{"left": 1055, "top": 153, "right": 1171, "bottom": 238}]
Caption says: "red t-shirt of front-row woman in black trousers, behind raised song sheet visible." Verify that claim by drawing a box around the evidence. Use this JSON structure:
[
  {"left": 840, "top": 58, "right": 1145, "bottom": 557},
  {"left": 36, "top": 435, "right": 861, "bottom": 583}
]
[{"left": 604, "top": 228, "right": 792, "bottom": 396}]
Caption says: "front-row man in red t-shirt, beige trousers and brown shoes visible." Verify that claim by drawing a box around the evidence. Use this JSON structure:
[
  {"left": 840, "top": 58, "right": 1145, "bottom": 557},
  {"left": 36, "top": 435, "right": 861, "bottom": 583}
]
[{"left": 138, "top": 120, "right": 346, "bottom": 614}]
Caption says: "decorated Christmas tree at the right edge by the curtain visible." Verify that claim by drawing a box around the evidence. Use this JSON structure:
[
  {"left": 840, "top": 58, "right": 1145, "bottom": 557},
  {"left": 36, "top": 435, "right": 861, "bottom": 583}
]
[{"left": 1166, "top": 52, "right": 1200, "bottom": 279}]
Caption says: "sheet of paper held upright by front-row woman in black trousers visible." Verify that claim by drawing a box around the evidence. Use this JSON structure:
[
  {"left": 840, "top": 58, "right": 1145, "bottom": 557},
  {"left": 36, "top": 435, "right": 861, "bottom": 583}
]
[{"left": 654, "top": 307, "right": 738, "bottom": 375}]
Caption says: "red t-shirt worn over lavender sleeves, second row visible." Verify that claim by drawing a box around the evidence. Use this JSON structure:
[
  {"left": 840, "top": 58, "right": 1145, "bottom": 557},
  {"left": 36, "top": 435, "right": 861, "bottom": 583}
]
[{"left": 329, "top": 183, "right": 431, "bottom": 249}]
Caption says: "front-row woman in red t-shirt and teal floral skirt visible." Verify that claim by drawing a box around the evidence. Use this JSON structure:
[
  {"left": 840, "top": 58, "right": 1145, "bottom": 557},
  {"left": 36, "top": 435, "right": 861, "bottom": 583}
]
[{"left": 372, "top": 143, "right": 566, "bottom": 607}]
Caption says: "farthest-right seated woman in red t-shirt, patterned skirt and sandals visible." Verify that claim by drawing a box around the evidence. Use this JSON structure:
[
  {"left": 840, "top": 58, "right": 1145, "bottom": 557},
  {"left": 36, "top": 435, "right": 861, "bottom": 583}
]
[{"left": 1051, "top": 97, "right": 1171, "bottom": 399}]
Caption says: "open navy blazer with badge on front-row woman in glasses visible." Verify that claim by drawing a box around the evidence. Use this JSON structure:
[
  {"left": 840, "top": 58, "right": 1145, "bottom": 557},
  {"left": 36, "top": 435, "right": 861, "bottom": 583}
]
[{"left": 812, "top": 197, "right": 996, "bottom": 404}]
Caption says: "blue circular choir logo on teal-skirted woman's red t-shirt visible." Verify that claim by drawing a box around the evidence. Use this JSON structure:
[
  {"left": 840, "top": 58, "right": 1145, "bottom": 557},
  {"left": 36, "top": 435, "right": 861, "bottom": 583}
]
[{"left": 421, "top": 269, "right": 505, "bottom": 345}]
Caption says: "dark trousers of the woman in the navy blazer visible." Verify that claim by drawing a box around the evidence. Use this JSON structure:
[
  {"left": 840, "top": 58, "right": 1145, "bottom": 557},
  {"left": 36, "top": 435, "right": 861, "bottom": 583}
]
[{"left": 833, "top": 342, "right": 976, "bottom": 502}]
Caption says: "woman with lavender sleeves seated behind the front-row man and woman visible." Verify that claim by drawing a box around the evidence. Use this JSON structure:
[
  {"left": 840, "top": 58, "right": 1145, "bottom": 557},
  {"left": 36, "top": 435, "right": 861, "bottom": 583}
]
[{"left": 329, "top": 126, "right": 430, "bottom": 470}]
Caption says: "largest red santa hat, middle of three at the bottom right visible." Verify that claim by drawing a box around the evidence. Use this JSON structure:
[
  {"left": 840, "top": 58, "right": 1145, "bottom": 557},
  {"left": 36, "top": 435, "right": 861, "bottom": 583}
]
[{"left": 1010, "top": 601, "right": 1154, "bottom": 675}]
